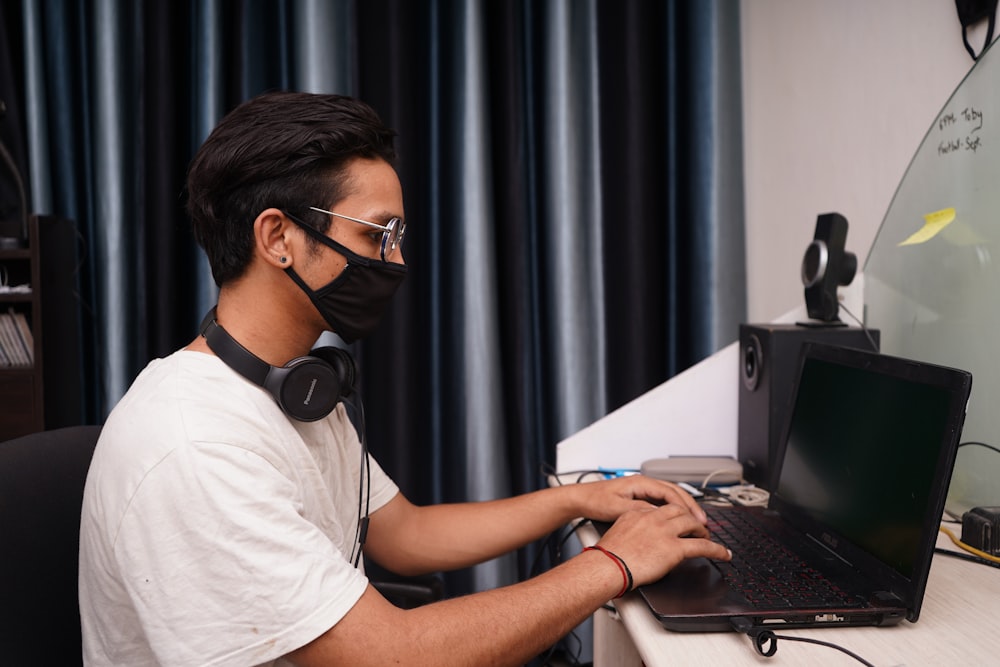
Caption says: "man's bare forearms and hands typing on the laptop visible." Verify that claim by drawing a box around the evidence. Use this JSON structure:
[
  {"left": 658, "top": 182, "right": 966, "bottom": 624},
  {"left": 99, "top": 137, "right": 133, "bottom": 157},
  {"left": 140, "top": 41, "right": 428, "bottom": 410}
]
[{"left": 300, "top": 486, "right": 731, "bottom": 667}]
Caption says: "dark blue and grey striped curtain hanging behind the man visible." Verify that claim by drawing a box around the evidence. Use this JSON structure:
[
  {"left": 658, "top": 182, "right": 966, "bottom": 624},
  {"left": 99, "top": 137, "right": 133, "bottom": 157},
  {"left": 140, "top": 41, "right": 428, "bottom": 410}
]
[{"left": 2, "top": 0, "right": 746, "bottom": 612}]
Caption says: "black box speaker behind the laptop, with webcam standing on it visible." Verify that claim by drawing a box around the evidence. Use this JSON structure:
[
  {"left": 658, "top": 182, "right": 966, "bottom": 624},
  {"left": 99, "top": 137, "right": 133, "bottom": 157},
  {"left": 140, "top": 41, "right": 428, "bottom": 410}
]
[{"left": 737, "top": 324, "right": 879, "bottom": 490}]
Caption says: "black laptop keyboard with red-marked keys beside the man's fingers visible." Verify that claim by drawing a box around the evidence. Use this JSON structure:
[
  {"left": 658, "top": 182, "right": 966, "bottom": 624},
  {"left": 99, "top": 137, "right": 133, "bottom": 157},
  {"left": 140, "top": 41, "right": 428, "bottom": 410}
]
[{"left": 704, "top": 507, "right": 864, "bottom": 610}]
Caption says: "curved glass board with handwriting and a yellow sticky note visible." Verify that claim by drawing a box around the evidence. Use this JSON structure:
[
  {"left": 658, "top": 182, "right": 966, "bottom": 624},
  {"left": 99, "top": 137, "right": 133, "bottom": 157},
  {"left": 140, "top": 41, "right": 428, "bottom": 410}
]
[{"left": 864, "top": 37, "right": 1000, "bottom": 514}]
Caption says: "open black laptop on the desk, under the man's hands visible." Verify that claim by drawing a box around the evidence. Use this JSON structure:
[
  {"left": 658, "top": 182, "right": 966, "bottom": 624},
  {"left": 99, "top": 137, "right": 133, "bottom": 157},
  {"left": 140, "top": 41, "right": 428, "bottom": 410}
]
[{"left": 612, "top": 343, "right": 972, "bottom": 631}]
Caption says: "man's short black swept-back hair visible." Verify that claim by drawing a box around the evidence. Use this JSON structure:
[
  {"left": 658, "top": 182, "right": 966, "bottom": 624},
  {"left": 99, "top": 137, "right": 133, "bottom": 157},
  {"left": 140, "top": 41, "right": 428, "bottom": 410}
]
[{"left": 187, "top": 92, "right": 396, "bottom": 286}]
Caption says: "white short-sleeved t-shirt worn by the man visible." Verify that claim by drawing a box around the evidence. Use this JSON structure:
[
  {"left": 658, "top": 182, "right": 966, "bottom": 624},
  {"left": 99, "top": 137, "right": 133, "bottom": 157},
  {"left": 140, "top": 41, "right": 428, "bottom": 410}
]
[{"left": 80, "top": 351, "right": 398, "bottom": 667}]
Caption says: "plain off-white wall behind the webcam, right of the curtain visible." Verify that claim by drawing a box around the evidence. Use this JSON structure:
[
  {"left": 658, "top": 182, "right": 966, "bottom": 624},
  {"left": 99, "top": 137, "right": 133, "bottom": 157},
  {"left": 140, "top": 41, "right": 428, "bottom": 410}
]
[{"left": 740, "top": 0, "right": 985, "bottom": 322}]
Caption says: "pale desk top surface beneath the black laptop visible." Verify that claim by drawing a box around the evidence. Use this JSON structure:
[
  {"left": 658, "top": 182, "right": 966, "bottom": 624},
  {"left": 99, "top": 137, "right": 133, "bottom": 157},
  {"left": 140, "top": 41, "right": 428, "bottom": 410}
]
[{"left": 578, "top": 526, "right": 1000, "bottom": 667}]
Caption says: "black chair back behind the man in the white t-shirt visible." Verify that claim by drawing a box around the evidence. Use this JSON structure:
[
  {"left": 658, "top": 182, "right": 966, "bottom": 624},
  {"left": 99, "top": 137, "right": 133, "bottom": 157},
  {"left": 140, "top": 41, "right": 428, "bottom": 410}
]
[{"left": 0, "top": 426, "right": 101, "bottom": 665}]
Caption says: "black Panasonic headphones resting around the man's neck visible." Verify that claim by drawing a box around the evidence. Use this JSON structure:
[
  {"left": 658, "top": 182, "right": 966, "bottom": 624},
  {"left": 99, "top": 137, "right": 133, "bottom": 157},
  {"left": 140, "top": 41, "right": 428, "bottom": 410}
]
[{"left": 199, "top": 308, "right": 356, "bottom": 421}]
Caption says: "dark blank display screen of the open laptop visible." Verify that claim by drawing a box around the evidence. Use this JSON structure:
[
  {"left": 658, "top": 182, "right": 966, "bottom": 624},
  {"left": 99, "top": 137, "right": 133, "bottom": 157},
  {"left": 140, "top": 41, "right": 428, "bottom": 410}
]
[{"left": 775, "top": 348, "right": 955, "bottom": 579}]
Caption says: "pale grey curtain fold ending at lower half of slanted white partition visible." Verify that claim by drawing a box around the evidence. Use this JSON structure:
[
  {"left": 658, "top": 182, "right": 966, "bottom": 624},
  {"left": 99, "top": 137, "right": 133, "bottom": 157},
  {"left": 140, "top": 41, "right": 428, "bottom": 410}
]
[{"left": 532, "top": 0, "right": 606, "bottom": 440}]
